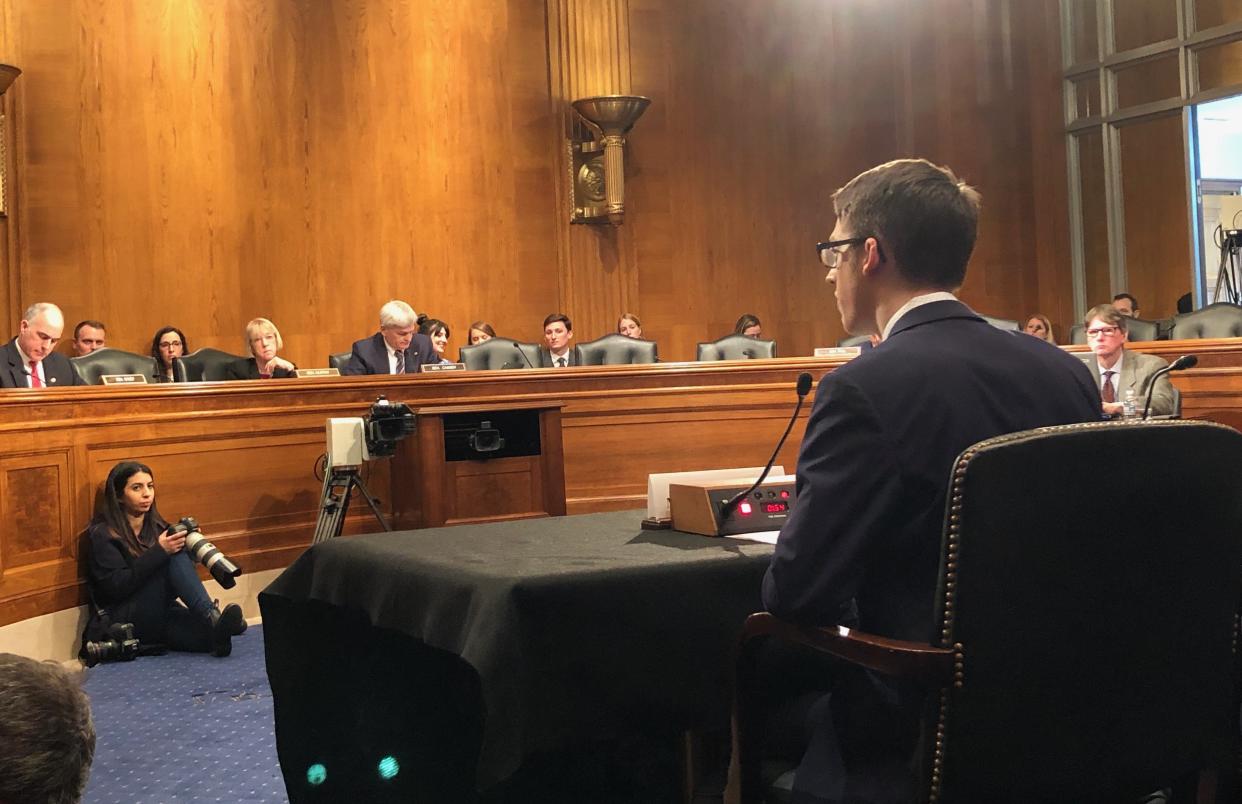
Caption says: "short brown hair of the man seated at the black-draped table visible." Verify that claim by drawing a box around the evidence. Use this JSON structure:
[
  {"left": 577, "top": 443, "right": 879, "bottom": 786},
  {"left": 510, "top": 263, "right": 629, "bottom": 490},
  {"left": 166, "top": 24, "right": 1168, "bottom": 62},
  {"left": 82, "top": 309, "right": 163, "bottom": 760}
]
[{"left": 832, "top": 159, "right": 980, "bottom": 291}]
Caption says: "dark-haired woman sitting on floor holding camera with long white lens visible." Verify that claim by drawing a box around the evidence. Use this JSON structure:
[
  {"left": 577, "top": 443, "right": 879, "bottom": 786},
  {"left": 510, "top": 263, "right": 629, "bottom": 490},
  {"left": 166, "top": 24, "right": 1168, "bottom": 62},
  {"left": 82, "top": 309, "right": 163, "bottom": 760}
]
[{"left": 86, "top": 461, "right": 246, "bottom": 656}]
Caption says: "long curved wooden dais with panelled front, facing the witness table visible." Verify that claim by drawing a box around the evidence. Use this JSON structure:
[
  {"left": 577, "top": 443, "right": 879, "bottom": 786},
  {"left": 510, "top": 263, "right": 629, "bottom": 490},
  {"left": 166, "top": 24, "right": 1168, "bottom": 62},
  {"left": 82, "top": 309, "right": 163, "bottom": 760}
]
[{"left": 7, "top": 339, "right": 1242, "bottom": 625}]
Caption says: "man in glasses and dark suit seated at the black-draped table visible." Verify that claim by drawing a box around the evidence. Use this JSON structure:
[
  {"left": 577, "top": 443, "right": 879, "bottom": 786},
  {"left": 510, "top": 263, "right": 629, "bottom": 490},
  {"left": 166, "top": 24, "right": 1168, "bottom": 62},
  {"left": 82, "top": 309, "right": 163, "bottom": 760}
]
[{"left": 763, "top": 160, "right": 1099, "bottom": 802}]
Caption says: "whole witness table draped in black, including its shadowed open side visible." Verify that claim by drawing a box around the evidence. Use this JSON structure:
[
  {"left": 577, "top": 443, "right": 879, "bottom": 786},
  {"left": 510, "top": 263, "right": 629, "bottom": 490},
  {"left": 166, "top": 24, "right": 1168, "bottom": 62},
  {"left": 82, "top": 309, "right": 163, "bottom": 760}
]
[{"left": 260, "top": 511, "right": 771, "bottom": 798}]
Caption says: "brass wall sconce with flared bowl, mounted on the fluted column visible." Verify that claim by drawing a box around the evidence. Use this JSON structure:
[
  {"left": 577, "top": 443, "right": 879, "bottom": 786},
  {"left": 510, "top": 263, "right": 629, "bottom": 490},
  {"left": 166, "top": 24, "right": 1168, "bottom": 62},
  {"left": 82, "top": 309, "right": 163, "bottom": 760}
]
[{"left": 569, "top": 94, "right": 651, "bottom": 226}]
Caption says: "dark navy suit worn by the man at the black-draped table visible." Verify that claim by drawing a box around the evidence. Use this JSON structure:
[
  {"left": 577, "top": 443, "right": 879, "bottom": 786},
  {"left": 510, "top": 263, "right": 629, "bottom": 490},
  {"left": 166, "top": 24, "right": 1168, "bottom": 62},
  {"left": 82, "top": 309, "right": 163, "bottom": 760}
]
[{"left": 763, "top": 301, "right": 1100, "bottom": 800}]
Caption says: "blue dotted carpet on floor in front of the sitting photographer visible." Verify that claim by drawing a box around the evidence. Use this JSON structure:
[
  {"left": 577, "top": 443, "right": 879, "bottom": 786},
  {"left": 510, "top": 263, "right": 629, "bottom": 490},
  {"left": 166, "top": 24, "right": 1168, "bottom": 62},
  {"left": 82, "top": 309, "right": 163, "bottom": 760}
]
[{"left": 83, "top": 626, "right": 288, "bottom": 804}]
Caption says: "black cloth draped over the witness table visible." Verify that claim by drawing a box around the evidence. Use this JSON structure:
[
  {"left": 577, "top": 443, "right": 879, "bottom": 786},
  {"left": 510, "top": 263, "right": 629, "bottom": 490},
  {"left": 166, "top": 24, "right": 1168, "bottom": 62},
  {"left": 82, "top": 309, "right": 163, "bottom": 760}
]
[{"left": 260, "top": 511, "right": 771, "bottom": 788}]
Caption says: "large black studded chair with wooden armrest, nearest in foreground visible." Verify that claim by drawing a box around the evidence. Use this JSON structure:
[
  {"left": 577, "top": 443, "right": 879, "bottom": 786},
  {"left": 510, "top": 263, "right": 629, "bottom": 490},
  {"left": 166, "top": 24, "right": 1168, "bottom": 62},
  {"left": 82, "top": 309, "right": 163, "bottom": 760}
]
[{"left": 735, "top": 421, "right": 1242, "bottom": 803}]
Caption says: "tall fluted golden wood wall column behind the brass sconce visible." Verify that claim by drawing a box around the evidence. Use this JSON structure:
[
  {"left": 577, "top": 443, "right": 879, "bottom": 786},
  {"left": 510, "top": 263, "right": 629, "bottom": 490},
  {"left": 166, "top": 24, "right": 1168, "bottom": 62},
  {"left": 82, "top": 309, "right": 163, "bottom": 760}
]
[{"left": 546, "top": 0, "right": 640, "bottom": 342}]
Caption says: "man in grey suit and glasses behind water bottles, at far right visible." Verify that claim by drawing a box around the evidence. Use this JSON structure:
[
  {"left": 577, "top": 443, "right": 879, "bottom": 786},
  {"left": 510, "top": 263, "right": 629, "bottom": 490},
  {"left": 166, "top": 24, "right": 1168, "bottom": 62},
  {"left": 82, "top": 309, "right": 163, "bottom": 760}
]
[{"left": 1083, "top": 298, "right": 1174, "bottom": 416}]
